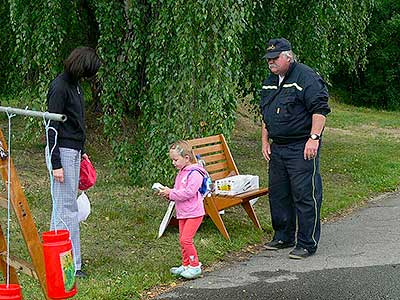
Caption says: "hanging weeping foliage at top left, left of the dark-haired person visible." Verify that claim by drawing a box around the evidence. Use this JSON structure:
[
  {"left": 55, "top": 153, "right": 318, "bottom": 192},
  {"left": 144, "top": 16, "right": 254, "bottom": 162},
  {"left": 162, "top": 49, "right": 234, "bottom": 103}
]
[{"left": 9, "top": 0, "right": 66, "bottom": 101}]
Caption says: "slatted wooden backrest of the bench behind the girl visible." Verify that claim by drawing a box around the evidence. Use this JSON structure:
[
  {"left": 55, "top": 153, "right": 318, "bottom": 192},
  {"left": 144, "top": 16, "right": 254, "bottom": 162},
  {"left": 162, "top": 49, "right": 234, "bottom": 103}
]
[{"left": 188, "top": 134, "right": 239, "bottom": 181}]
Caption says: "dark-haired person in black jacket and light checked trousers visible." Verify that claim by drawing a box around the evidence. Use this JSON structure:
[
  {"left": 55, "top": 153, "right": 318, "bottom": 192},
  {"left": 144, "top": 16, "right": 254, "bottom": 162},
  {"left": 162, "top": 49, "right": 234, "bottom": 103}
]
[{"left": 47, "top": 47, "right": 101, "bottom": 277}]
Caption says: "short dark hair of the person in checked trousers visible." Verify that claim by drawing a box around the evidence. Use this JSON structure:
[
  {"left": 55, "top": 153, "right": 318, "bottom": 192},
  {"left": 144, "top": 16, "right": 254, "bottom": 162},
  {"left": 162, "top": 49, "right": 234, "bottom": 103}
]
[{"left": 64, "top": 47, "right": 101, "bottom": 79}]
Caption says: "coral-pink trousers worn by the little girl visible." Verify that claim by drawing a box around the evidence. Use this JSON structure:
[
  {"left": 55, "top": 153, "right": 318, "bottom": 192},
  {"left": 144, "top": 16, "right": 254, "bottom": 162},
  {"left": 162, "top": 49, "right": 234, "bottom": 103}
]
[{"left": 179, "top": 216, "right": 203, "bottom": 267}]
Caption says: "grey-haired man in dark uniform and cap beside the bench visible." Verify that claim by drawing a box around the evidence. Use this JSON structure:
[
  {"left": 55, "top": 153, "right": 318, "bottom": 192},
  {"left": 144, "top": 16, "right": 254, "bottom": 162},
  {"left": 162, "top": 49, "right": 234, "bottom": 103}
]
[{"left": 260, "top": 38, "right": 330, "bottom": 259}]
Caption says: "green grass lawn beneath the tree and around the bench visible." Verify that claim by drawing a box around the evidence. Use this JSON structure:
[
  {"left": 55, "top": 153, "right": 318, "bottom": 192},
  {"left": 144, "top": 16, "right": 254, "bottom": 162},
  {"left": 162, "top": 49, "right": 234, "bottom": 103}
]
[{"left": 0, "top": 95, "right": 400, "bottom": 300}]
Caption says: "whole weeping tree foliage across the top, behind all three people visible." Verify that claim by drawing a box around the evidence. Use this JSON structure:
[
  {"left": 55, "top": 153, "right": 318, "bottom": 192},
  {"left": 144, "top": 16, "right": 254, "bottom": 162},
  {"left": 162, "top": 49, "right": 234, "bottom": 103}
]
[{"left": 0, "top": 0, "right": 373, "bottom": 184}]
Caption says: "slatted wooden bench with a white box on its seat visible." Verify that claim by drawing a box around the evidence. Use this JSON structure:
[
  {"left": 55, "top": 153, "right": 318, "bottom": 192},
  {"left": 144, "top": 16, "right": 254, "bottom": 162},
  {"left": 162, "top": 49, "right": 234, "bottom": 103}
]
[{"left": 188, "top": 134, "right": 268, "bottom": 240}]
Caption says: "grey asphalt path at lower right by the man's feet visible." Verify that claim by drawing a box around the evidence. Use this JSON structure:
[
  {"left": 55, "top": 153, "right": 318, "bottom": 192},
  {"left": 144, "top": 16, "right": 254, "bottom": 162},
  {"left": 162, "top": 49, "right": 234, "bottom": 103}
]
[{"left": 156, "top": 192, "right": 400, "bottom": 300}]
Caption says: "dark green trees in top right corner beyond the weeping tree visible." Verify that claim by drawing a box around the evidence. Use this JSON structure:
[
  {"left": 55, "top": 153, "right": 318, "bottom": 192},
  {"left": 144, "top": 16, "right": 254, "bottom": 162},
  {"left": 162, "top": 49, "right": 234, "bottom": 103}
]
[{"left": 341, "top": 0, "right": 400, "bottom": 110}]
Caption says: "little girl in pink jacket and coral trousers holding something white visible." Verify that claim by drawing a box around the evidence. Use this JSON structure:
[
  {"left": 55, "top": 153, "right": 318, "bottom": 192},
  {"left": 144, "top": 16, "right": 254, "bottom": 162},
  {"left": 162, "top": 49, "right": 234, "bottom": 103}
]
[{"left": 160, "top": 141, "right": 206, "bottom": 279}]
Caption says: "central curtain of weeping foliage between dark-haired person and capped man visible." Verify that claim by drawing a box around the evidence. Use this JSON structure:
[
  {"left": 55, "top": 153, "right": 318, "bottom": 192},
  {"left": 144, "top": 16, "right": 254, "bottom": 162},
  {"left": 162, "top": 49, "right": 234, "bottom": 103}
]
[{"left": 96, "top": 0, "right": 245, "bottom": 183}]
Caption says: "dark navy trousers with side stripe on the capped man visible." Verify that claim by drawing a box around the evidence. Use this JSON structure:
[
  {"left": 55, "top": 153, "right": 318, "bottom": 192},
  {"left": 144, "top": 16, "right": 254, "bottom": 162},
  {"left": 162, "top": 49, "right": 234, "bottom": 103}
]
[{"left": 269, "top": 141, "right": 322, "bottom": 253}]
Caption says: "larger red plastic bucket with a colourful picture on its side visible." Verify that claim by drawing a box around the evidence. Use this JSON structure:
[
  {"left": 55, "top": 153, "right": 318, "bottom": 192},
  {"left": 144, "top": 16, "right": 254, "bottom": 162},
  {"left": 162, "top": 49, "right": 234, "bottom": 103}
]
[{"left": 42, "top": 229, "right": 77, "bottom": 299}]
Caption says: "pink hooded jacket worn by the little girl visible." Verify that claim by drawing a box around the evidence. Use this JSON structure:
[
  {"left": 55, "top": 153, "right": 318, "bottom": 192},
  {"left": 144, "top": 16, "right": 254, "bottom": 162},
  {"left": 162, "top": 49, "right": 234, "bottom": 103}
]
[{"left": 169, "top": 164, "right": 205, "bottom": 219}]
